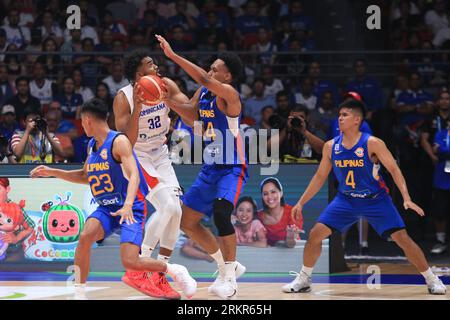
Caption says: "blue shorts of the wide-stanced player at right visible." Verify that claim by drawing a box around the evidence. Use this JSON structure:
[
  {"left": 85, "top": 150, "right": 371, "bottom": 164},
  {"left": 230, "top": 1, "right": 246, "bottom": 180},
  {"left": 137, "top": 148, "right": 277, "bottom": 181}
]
[{"left": 317, "top": 193, "right": 405, "bottom": 239}]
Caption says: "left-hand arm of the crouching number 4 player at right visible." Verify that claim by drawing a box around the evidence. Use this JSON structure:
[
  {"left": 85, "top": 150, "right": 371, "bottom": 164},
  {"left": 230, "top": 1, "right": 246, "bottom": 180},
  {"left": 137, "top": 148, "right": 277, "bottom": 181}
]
[{"left": 292, "top": 140, "right": 333, "bottom": 221}]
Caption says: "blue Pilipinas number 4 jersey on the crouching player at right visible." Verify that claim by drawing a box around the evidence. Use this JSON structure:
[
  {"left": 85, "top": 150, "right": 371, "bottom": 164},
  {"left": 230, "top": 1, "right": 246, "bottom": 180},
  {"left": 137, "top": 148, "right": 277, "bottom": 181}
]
[{"left": 331, "top": 132, "right": 388, "bottom": 198}]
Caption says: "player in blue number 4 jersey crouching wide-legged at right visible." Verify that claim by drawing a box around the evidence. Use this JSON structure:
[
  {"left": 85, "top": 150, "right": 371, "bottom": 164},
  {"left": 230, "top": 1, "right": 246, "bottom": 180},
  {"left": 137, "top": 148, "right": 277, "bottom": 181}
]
[{"left": 282, "top": 99, "right": 447, "bottom": 294}]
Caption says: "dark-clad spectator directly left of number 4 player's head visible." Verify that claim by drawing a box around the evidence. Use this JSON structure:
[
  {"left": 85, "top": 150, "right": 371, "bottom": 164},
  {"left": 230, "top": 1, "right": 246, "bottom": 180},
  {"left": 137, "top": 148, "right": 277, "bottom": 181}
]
[{"left": 308, "top": 91, "right": 337, "bottom": 141}]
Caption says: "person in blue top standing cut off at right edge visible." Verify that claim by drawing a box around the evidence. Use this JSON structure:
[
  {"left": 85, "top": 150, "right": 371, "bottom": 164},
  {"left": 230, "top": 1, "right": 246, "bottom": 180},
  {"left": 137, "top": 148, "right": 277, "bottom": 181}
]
[{"left": 431, "top": 117, "right": 450, "bottom": 254}]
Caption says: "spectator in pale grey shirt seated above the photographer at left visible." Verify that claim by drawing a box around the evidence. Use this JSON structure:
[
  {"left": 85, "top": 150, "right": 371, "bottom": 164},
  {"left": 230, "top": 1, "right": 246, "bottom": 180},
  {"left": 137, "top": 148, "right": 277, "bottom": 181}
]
[{"left": 30, "top": 61, "right": 57, "bottom": 111}]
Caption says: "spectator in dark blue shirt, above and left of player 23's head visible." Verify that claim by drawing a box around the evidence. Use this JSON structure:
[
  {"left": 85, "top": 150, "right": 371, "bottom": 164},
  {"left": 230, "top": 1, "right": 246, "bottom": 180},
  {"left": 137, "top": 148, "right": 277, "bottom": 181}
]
[{"left": 54, "top": 77, "right": 83, "bottom": 120}]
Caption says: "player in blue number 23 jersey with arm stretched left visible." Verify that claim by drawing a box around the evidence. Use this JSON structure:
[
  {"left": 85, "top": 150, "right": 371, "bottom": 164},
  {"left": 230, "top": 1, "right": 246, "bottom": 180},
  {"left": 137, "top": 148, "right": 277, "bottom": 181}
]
[{"left": 30, "top": 99, "right": 196, "bottom": 298}]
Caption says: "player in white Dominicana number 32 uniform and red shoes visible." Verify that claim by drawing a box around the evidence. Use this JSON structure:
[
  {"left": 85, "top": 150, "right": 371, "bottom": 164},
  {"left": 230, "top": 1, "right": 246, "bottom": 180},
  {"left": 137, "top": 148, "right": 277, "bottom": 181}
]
[{"left": 113, "top": 50, "right": 196, "bottom": 299}]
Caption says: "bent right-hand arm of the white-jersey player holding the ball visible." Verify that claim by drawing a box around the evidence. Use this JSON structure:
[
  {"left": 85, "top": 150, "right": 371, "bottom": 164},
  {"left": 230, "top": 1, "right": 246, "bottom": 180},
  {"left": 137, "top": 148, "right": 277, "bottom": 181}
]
[{"left": 163, "top": 78, "right": 200, "bottom": 127}]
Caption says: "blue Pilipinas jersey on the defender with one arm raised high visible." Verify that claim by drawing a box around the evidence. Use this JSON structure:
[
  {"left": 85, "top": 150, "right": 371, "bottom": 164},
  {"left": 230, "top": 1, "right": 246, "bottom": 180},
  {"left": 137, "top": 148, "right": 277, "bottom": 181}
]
[{"left": 198, "top": 87, "right": 247, "bottom": 166}]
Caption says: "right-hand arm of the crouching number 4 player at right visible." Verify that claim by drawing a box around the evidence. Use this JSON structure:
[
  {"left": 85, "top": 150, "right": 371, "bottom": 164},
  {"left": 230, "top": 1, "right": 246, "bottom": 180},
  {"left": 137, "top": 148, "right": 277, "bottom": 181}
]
[{"left": 367, "top": 137, "right": 425, "bottom": 216}]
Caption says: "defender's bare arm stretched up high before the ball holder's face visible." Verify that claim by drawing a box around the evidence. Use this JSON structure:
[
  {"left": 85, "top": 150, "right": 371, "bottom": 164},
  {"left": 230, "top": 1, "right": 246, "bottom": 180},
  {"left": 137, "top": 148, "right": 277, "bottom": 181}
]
[{"left": 156, "top": 35, "right": 240, "bottom": 116}]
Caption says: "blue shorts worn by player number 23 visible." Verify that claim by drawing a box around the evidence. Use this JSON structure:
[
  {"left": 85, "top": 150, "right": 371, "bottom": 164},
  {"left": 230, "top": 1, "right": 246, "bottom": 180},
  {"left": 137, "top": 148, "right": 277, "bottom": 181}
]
[{"left": 88, "top": 206, "right": 145, "bottom": 247}]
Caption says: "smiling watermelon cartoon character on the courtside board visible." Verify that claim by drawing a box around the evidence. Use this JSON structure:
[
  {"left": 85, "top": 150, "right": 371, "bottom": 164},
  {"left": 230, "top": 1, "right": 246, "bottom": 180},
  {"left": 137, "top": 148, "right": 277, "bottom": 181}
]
[{"left": 41, "top": 192, "right": 84, "bottom": 243}]
